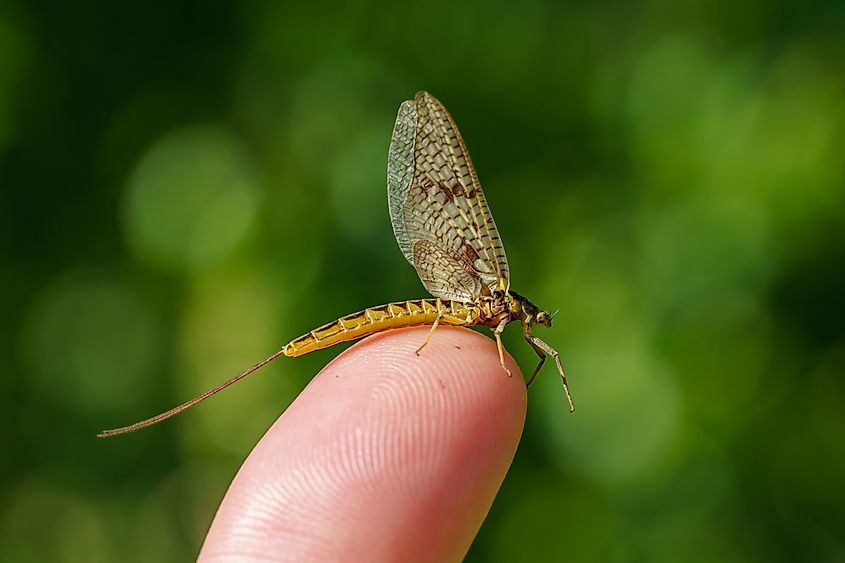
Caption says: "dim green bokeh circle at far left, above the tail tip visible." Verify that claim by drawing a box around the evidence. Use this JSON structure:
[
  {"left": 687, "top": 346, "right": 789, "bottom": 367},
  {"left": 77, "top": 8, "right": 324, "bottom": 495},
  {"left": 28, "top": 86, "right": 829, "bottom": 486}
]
[{"left": 23, "top": 271, "right": 158, "bottom": 416}]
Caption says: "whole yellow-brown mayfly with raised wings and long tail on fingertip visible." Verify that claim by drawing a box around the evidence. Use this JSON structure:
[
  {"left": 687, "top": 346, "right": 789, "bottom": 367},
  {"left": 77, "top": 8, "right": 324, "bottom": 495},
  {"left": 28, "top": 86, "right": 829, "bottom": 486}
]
[{"left": 98, "top": 92, "right": 575, "bottom": 437}]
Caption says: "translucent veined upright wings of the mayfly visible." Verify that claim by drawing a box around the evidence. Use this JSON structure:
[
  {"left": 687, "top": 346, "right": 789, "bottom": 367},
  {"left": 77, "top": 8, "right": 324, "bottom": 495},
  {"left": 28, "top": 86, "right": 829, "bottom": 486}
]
[{"left": 387, "top": 92, "right": 510, "bottom": 301}]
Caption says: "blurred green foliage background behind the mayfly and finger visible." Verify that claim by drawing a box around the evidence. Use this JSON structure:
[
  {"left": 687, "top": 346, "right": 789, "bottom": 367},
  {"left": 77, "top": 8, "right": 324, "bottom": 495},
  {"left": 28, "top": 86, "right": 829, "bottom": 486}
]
[{"left": 0, "top": 0, "right": 845, "bottom": 562}]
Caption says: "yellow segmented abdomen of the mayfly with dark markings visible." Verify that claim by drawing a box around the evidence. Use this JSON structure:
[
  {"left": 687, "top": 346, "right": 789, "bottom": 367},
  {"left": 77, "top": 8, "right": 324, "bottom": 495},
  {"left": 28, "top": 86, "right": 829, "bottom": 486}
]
[{"left": 284, "top": 299, "right": 478, "bottom": 358}]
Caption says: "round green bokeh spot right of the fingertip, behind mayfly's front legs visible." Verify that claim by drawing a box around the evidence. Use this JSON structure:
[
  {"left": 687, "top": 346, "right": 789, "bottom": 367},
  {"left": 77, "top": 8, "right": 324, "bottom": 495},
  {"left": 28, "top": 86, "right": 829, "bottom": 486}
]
[{"left": 538, "top": 333, "right": 681, "bottom": 484}]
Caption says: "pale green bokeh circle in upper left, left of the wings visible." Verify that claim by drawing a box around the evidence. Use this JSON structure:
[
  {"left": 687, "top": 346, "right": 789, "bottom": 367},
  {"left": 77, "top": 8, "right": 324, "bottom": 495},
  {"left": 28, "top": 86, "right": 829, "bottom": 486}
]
[{"left": 126, "top": 127, "right": 260, "bottom": 271}]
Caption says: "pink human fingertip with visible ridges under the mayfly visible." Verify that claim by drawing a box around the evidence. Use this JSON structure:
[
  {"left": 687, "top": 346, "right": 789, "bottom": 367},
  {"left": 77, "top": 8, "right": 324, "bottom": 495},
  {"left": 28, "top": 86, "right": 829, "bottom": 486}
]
[{"left": 200, "top": 327, "right": 526, "bottom": 561}]
